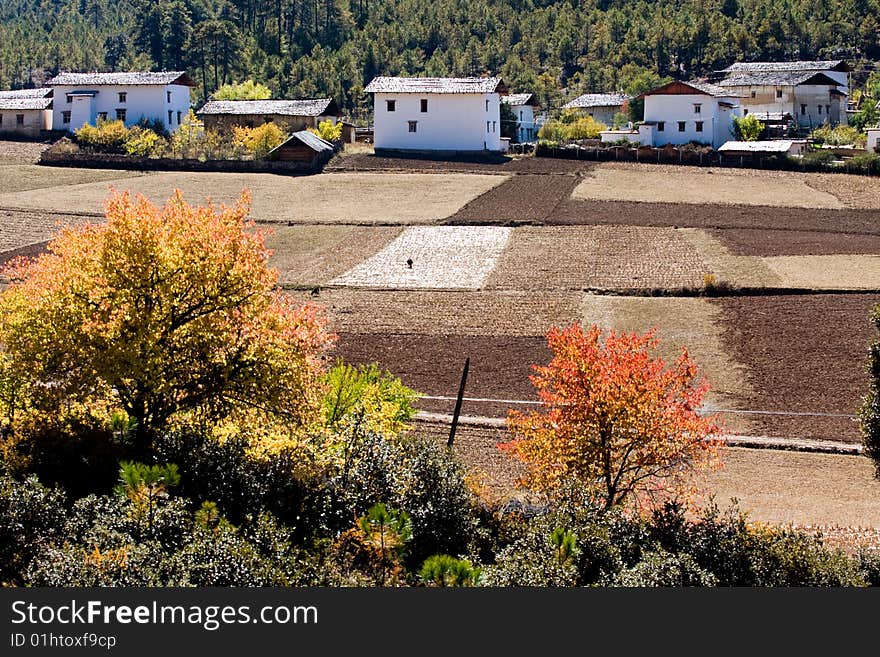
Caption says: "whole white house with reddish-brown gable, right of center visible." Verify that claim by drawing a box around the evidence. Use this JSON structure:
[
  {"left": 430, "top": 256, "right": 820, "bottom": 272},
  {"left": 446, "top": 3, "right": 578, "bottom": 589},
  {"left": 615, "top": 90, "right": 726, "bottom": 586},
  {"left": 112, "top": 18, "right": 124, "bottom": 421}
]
[{"left": 639, "top": 80, "right": 739, "bottom": 148}]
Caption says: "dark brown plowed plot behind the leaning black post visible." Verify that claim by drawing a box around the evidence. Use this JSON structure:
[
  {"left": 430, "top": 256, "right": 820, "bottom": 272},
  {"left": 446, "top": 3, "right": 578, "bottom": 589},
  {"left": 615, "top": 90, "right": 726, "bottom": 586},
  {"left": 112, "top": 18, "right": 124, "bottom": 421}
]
[{"left": 335, "top": 333, "right": 550, "bottom": 417}]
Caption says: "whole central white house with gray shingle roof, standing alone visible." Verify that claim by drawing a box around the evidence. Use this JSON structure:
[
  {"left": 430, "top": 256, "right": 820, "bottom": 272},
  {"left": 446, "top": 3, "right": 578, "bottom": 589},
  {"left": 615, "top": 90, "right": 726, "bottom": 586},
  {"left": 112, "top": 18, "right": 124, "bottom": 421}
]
[{"left": 364, "top": 77, "right": 507, "bottom": 152}]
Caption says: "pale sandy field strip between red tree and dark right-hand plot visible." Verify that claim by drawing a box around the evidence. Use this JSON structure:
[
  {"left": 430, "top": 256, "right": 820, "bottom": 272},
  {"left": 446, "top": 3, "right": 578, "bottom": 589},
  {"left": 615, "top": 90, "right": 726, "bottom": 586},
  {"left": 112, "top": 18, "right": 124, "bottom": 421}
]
[{"left": 581, "top": 294, "right": 751, "bottom": 435}]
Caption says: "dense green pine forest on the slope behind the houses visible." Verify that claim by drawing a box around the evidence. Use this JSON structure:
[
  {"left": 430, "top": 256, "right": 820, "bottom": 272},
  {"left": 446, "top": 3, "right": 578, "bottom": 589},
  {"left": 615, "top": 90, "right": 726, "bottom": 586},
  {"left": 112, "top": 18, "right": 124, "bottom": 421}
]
[{"left": 0, "top": 0, "right": 880, "bottom": 115}]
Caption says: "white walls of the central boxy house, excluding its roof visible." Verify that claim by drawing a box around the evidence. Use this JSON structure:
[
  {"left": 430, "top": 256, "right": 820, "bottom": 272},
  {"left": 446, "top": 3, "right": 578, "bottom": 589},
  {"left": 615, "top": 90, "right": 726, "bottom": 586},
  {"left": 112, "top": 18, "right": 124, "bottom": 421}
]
[{"left": 373, "top": 93, "right": 501, "bottom": 151}]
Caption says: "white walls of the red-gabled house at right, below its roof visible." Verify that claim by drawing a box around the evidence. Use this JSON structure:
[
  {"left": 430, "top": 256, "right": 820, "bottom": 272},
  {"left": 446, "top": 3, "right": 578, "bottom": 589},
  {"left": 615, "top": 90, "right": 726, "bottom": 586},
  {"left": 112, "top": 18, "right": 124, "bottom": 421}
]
[{"left": 645, "top": 94, "right": 735, "bottom": 148}]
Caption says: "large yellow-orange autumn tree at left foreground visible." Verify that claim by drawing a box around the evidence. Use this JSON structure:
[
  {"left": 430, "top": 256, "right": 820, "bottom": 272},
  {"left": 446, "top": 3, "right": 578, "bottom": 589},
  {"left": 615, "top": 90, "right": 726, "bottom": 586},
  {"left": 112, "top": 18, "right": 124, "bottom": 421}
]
[{"left": 0, "top": 192, "right": 334, "bottom": 454}]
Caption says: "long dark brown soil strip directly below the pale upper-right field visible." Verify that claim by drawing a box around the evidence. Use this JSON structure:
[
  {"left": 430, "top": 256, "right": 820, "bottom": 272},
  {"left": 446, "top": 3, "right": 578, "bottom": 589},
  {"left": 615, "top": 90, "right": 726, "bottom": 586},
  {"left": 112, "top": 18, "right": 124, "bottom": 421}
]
[{"left": 552, "top": 199, "right": 880, "bottom": 236}]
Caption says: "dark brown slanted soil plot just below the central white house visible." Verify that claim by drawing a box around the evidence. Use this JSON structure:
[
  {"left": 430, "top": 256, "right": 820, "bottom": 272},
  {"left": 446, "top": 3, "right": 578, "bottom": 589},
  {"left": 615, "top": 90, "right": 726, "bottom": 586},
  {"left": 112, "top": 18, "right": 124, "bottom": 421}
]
[{"left": 445, "top": 174, "right": 581, "bottom": 224}]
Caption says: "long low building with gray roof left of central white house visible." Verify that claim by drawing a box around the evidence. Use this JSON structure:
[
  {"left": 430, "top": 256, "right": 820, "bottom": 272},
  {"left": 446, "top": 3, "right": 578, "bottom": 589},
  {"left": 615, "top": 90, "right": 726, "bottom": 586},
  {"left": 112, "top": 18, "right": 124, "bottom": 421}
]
[{"left": 196, "top": 98, "right": 339, "bottom": 131}]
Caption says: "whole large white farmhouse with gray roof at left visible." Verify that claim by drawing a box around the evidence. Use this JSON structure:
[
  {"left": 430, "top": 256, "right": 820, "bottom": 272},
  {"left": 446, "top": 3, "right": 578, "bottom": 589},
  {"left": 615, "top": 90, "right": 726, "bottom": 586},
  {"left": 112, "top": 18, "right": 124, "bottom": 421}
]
[{"left": 46, "top": 71, "right": 196, "bottom": 132}]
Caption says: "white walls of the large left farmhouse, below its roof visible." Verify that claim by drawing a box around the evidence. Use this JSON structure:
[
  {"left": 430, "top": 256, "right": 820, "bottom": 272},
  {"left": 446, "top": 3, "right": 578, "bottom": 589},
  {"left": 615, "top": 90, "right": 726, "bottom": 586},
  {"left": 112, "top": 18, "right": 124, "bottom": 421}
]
[{"left": 52, "top": 84, "right": 190, "bottom": 132}]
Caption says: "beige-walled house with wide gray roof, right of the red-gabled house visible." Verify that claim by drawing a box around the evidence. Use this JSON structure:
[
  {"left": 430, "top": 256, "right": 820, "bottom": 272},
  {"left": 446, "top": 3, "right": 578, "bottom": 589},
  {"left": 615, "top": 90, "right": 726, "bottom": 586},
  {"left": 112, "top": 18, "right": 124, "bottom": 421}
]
[{"left": 717, "top": 71, "right": 847, "bottom": 129}]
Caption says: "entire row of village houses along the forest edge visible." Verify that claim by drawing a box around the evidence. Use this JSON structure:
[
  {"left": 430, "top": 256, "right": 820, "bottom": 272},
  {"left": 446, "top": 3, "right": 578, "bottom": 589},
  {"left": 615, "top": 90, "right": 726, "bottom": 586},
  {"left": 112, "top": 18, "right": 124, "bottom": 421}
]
[{"left": 0, "top": 60, "right": 880, "bottom": 159}]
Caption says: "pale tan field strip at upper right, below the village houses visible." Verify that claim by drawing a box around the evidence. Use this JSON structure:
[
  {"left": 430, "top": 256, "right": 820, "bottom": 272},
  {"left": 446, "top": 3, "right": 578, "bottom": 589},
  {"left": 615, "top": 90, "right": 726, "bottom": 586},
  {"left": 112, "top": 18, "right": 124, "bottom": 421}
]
[{"left": 572, "top": 165, "right": 844, "bottom": 209}]
